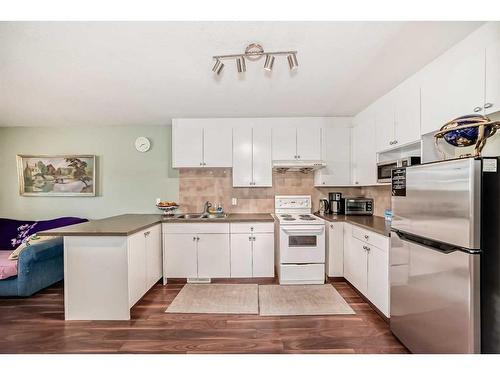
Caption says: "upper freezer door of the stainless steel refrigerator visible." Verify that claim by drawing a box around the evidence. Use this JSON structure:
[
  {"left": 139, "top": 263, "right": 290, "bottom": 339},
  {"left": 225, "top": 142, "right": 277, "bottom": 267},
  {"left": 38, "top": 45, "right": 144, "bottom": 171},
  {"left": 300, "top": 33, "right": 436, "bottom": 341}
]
[{"left": 392, "top": 158, "right": 481, "bottom": 249}]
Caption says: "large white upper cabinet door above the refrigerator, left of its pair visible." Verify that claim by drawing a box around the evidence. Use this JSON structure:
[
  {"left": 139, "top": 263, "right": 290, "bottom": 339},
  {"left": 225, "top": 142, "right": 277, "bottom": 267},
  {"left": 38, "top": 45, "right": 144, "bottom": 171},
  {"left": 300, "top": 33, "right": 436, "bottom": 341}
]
[{"left": 422, "top": 50, "right": 485, "bottom": 134}]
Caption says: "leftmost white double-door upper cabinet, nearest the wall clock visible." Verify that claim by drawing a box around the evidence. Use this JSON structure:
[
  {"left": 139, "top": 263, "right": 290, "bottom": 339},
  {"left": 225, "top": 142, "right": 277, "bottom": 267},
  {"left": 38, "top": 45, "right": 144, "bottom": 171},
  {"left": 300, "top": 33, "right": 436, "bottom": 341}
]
[{"left": 172, "top": 118, "right": 233, "bottom": 168}]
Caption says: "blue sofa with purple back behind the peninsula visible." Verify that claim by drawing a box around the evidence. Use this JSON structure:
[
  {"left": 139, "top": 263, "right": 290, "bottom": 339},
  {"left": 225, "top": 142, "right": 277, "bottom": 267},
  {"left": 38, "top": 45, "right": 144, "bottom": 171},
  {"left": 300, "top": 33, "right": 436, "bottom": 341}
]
[{"left": 0, "top": 218, "right": 87, "bottom": 297}]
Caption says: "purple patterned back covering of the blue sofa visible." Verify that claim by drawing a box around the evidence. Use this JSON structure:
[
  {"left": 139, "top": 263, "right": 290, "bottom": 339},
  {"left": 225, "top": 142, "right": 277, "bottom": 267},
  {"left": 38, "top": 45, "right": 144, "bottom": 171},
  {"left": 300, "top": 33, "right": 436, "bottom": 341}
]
[{"left": 0, "top": 217, "right": 88, "bottom": 250}]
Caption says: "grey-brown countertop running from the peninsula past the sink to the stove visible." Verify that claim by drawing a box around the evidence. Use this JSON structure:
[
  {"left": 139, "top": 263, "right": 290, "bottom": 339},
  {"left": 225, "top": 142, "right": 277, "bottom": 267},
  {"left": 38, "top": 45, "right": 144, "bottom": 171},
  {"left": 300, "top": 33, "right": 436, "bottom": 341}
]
[{"left": 38, "top": 214, "right": 274, "bottom": 236}]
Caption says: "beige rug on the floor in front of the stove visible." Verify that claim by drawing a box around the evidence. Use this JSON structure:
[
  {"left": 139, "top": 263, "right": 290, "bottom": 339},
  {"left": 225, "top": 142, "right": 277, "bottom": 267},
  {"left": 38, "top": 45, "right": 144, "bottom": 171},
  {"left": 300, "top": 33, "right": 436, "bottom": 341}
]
[{"left": 259, "top": 284, "right": 355, "bottom": 316}]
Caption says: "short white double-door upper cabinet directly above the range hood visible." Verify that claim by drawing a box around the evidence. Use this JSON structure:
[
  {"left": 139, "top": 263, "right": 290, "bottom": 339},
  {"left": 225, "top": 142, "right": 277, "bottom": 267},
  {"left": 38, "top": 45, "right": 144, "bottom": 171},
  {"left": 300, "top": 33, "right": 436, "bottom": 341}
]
[{"left": 270, "top": 117, "right": 325, "bottom": 160}]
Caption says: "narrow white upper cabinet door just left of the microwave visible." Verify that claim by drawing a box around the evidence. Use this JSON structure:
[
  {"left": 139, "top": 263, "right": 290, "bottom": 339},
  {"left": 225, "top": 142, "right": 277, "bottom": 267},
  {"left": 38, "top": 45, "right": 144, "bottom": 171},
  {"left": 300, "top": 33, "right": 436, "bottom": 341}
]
[{"left": 352, "top": 112, "right": 377, "bottom": 186}]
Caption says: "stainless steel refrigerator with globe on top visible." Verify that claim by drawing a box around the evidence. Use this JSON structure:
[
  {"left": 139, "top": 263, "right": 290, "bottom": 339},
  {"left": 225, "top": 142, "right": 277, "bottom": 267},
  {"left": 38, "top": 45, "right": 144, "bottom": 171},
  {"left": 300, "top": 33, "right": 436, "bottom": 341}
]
[{"left": 389, "top": 158, "right": 500, "bottom": 353}]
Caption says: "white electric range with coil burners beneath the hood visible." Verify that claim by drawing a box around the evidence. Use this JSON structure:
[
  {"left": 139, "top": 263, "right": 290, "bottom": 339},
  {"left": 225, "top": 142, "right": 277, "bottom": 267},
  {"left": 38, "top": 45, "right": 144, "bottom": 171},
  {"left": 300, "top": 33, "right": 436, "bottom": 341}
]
[{"left": 274, "top": 195, "right": 325, "bottom": 284}]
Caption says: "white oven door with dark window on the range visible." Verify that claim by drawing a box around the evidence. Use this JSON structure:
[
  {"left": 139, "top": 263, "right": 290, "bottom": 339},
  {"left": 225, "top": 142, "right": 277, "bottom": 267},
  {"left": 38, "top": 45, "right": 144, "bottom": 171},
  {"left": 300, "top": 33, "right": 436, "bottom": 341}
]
[{"left": 280, "top": 225, "right": 325, "bottom": 264}]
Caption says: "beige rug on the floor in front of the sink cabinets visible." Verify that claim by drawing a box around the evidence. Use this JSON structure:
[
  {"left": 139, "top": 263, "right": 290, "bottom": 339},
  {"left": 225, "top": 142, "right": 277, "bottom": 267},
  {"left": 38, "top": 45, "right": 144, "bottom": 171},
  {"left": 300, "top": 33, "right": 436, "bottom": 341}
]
[{"left": 165, "top": 284, "right": 259, "bottom": 314}]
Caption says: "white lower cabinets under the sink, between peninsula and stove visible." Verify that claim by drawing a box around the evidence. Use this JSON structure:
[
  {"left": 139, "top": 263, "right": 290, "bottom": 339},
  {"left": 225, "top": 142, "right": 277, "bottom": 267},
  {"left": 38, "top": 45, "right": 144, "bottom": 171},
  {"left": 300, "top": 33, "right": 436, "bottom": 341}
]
[{"left": 163, "top": 223, "right": 274, "bottom": 283}]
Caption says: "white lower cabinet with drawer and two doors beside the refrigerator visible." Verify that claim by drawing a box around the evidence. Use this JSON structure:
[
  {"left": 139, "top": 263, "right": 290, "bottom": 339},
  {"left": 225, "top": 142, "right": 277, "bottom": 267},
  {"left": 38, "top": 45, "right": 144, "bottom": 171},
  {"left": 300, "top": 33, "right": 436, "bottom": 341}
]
[{"left": 344, "top": 224, "right": 389, "bottom": 317}]
